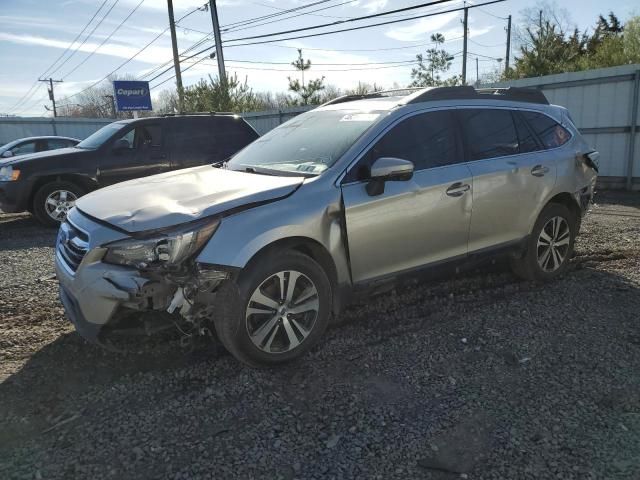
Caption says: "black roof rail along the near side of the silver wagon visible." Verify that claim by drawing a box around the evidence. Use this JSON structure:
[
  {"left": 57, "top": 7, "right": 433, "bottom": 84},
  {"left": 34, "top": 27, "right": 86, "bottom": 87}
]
[{"left": 407, "top": 85, "right": 549, "bottom": 105}]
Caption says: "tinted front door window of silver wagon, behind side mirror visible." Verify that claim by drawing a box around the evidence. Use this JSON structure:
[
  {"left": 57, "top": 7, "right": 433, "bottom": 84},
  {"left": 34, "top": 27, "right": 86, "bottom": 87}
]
[{"left": 346, "top": 111, "right": 457, "bottom": 181}]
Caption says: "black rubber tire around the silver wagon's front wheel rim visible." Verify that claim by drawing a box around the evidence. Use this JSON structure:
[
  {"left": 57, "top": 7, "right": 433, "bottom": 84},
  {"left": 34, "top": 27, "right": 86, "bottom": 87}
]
[{"left": 214, "top": 250, "right": 332, "bottom": 368}]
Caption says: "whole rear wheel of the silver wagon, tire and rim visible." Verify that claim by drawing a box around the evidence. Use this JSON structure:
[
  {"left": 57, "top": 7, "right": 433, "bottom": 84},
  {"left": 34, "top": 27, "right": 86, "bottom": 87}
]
[{"left": 511, "top": 203, "right": 577, "bottom": 281}]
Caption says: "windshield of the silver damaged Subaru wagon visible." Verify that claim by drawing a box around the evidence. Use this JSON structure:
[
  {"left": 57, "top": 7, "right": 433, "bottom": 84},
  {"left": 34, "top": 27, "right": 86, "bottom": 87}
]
[{"left": 227, "top": 110, "right": 381, "bottom": 175}]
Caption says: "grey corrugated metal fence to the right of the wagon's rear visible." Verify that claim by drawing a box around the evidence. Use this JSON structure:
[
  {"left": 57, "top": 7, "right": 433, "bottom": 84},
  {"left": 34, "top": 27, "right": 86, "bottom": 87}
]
[{"left": 494, "top": 64, "right": 640, "bottom": 190}]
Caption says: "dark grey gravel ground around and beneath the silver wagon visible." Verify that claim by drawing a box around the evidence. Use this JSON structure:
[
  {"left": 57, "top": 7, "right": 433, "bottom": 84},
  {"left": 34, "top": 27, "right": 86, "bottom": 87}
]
[{"left": 0, "top": 194, "right": 640, "bottom": 479}]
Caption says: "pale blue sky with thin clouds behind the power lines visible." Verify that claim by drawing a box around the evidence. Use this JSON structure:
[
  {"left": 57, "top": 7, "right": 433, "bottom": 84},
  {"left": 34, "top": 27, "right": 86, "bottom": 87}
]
[{"left": 0, "top": 0, "right": 640, "bottom": 116}]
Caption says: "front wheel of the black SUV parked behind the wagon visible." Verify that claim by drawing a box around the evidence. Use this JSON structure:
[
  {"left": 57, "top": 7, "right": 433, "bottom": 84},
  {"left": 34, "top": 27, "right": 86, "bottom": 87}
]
[{"left": 32, "top": 181, "right": 85, "bottom": 227}]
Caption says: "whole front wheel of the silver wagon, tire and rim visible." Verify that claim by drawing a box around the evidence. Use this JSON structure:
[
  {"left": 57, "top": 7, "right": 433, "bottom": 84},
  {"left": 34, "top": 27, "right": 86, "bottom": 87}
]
[{"left": 215, "top": 251, "right": 331, "bottom": 367}]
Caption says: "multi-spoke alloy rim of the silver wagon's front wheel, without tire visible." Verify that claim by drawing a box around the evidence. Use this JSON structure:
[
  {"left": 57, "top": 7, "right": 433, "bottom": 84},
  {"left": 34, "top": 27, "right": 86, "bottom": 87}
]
[{"left": 245, "top": 270, "right": 320, "bottom": 354}]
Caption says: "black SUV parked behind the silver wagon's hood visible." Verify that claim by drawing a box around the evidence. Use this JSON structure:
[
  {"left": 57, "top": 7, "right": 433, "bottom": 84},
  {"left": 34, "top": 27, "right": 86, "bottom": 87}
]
[{"left": 0, "top": 114, "right": 258, "bottom": 226}]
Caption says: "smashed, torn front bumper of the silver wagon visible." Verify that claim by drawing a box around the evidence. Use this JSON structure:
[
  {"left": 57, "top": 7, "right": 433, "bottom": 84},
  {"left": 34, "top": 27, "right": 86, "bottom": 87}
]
[{"left": 55, "top": 228, "right": 233, "bottom": 342}]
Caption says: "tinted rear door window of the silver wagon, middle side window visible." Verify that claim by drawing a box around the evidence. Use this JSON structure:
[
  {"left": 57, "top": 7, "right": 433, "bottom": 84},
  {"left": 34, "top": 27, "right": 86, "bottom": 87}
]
[{"left": 459, "top": 108, "right": 519, "bottom": 160}]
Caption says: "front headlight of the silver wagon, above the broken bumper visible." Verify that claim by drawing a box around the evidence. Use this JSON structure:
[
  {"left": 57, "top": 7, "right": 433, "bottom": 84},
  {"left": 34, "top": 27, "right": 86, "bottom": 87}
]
[{"left": 104, "top": 219, "right": 220, "bottom": 268}]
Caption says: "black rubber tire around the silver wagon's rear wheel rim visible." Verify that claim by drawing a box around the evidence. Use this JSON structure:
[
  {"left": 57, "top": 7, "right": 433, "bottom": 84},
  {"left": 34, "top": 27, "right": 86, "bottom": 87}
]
[{"left": 511, "top": 203, "right": 578, "bottom": 282}]
